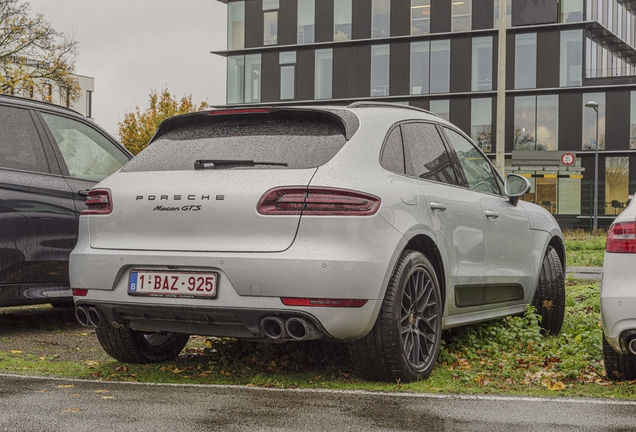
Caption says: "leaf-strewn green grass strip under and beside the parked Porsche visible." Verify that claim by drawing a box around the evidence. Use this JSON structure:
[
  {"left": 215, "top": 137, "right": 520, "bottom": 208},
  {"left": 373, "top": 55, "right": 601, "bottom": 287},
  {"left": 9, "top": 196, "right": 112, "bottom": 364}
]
[{"left": 0, "top": 281, "right": 636, "bottom": 399}]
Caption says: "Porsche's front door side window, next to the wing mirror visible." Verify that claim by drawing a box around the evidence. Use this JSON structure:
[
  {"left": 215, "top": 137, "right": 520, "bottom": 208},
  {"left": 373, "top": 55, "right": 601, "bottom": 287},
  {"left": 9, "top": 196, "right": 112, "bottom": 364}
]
[{"left": 444, "top": 128, "right": 501, "bottom": 195}]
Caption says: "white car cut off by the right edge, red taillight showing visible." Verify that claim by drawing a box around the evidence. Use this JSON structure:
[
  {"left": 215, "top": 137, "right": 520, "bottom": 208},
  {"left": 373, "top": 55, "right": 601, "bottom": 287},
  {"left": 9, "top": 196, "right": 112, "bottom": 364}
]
[{"left": 601, "top": 200, "right": 636, "bottom": 380}]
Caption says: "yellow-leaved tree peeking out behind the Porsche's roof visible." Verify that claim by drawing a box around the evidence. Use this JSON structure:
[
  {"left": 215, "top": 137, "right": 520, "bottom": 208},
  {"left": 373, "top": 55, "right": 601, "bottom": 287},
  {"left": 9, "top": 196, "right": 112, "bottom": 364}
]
[{"left": 118, "top": 89, "right": 208, "bottom": 154}]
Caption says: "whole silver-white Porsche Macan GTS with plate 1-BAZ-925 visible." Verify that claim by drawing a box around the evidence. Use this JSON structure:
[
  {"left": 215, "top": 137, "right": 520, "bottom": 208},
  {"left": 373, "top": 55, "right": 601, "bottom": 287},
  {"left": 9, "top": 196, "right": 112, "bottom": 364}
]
[{"left": 70, "top": 103, "right": 565, "bottom": 382}]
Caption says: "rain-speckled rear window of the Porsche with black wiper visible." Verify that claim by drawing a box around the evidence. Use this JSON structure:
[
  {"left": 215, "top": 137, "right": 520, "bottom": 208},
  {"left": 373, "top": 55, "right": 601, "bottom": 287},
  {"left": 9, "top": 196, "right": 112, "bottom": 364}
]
[{"left": 122, "top": 115, "right": 346, "bottom": 172}]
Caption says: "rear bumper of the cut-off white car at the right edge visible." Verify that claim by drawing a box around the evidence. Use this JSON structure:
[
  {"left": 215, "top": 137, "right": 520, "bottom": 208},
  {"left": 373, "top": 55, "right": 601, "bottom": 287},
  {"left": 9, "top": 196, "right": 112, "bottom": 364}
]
[{"left": 601, "top": 253, "right": 636, "bottom": 354}]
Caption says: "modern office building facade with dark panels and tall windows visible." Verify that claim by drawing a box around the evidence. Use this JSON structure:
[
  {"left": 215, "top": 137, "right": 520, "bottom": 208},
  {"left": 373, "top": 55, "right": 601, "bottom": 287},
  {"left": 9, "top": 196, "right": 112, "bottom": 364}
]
[{"left": 216, "top": 0, "right": 636, "bottom": 227}]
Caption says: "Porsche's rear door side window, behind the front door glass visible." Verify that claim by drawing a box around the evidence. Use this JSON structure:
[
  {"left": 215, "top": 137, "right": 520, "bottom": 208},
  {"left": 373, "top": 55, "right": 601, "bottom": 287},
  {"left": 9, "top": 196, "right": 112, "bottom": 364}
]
[{"left": 402, "top": 123, "right": 457, "bottom": 184}]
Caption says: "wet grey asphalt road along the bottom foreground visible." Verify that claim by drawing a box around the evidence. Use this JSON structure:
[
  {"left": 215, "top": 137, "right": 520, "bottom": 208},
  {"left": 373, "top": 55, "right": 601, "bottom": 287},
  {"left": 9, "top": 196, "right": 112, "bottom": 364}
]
[{"left": 0, "top": 375, "right": 636, "bottom": 432}]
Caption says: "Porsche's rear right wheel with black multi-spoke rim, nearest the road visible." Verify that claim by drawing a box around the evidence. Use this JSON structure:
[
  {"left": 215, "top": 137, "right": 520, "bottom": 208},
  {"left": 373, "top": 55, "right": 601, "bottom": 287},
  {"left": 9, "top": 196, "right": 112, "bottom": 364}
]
[{"left": 349, "top": 250, "right": 442, "bottom": 382}]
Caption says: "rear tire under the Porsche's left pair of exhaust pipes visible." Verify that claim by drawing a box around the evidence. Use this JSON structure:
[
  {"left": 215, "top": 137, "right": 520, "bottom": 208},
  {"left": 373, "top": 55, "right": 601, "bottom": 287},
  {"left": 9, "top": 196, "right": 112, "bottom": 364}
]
[{"left": 95, "top": 327, "right": 190, "bottom": 364}]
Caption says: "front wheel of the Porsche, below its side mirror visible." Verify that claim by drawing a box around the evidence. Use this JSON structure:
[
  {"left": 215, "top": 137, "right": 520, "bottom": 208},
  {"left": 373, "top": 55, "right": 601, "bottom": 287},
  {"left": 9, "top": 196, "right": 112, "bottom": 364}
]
[{"left": 532, "top": 246, "right": 565, "bottom": 335}]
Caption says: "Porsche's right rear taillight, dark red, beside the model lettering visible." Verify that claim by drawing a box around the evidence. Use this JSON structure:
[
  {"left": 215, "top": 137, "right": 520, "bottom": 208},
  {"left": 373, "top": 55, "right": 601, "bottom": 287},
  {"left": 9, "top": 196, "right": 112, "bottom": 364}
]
[{"left": 257, "top": 187, "right": 381, "bottom": 216}]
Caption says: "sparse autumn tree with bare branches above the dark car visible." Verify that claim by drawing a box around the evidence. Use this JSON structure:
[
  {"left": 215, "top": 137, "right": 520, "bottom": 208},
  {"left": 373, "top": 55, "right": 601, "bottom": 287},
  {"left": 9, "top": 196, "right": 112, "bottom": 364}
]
[{"left": 0, "top": 0, "right": 80, "bottom": 103}]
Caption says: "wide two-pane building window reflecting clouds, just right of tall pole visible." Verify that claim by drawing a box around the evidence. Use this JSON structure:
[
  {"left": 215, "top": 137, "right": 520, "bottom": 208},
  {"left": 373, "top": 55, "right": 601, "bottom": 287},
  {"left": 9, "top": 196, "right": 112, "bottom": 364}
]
[{"left": 514, "top": 95, "right": 559, "bottom": 151}]
